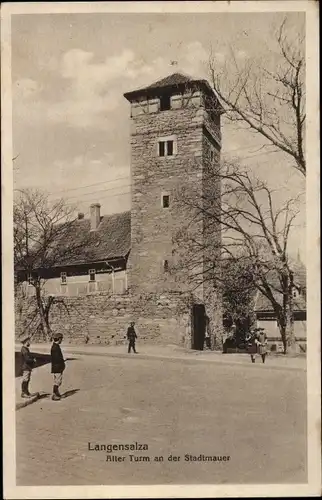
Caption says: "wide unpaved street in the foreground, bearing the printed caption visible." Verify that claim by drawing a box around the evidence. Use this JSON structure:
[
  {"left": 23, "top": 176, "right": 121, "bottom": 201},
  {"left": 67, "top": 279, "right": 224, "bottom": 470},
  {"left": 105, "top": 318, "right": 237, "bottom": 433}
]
[{"left": 16, "top": 355, "right": 307, "bottom": 485}]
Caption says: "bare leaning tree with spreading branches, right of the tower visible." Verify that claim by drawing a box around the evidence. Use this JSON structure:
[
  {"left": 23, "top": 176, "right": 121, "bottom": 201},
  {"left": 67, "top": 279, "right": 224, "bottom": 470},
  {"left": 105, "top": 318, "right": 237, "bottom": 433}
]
[{"left": 177, "top": 159, "right": 300, "bottom": 353}]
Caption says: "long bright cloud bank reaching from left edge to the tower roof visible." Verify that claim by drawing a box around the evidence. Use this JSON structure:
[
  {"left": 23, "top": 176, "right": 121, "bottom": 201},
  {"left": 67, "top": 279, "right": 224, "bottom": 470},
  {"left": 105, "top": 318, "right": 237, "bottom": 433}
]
[{"left": 16, "top": 41, "right": 208, "bottom": 129}]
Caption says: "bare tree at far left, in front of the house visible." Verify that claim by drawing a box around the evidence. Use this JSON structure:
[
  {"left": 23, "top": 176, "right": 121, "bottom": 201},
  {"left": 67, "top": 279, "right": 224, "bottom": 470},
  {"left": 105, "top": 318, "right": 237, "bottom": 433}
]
[{"left": 14, "top": 189, "right": 90, "bottom": 338}]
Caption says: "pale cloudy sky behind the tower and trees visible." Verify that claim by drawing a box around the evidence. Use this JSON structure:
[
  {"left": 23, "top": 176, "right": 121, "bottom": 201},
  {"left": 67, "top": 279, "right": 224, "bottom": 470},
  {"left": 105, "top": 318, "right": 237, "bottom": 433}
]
[{"left": 11, "top": 13, "right": 305, "bottom": 261}]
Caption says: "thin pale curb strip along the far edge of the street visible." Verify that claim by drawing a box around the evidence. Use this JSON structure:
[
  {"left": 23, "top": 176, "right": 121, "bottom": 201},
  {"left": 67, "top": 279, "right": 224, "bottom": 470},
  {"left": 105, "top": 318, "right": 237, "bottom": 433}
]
[{"left": 15, "top": 346, "right": 306, "bottom": 371}]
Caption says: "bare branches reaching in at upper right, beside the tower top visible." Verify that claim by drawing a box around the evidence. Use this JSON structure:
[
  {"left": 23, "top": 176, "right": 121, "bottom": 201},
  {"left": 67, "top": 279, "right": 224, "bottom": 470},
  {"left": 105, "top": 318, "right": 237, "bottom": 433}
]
[{"left": 209, "top": 20, "right": 306, "bottom": 176}]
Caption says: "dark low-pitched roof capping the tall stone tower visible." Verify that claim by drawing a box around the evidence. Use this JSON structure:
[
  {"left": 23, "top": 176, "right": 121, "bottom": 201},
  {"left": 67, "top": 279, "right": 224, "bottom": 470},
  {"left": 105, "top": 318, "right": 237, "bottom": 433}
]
[{"left": 124, "top": 73, "right": 218, "bottom": 110}]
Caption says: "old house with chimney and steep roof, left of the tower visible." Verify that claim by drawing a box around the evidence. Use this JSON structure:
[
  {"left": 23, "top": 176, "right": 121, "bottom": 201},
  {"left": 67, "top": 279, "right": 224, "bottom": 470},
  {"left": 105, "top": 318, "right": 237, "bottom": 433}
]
[{"left": 19, "top": 203, "right": 131, "bottom": 296}]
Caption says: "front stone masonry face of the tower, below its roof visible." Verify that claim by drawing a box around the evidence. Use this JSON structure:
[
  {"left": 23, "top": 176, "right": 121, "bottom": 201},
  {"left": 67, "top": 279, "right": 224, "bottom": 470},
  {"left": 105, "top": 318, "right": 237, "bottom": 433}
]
[{"left": 129, "top": 98, "right": 203, "bottom": 293}]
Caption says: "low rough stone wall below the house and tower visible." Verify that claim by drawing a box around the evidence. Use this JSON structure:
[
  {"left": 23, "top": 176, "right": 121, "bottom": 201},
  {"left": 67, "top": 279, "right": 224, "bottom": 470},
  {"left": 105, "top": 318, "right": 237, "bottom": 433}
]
[{"left": 16, "top": 293, "right": 191, "bottom": 347}]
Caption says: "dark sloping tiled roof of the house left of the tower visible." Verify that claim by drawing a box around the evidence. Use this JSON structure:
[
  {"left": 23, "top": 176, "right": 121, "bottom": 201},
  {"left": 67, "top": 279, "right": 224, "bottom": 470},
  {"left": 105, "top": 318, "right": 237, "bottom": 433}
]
[{"left": 55, "top": 211, "right": 131, "bottom": 267}]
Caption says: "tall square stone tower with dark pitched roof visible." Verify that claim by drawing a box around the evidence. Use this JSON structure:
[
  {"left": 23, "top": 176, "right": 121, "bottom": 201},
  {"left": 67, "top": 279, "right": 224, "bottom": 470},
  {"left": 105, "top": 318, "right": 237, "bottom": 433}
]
[{"left": 124, "top": 73, "right": 222, "bottom": 330}]
